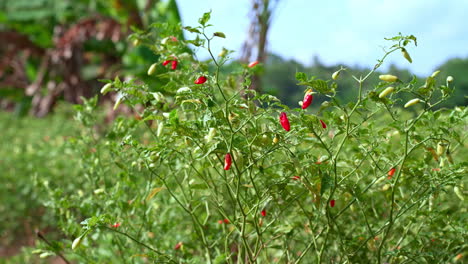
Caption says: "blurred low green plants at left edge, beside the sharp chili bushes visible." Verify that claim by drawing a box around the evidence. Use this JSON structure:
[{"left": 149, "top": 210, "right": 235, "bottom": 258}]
[{"left": 0, "top": 107, "right": 81, "bottom": 254}]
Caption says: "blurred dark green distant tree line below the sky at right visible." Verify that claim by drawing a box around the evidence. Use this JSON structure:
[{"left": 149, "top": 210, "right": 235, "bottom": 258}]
[{"left": 261, "top": 54, "right": 468, "bottom": 108}]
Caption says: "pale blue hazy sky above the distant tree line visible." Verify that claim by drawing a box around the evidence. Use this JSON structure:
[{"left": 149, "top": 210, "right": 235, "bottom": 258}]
[{"left": 177, "top": 0, "right": 468, "bottom": 75}]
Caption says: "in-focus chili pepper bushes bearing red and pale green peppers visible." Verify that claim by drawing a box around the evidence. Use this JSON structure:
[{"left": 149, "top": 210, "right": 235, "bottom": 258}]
[{"left": 5, "top": 13, "right": 467, "bottom": 263}]
